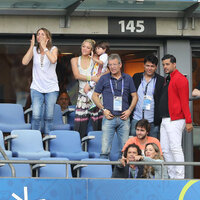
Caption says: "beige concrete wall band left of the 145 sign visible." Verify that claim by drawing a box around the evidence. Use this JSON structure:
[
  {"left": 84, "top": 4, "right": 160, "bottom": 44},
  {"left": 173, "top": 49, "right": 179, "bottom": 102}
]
[{"left": 0, "top": 16, "right": 108, "bottom": 34}]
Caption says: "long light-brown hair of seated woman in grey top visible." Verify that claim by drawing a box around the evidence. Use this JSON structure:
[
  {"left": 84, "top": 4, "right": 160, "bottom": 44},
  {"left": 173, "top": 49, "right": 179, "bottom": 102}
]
[{"left": 143, "top": 143, "right": 163, "bottom": 178}]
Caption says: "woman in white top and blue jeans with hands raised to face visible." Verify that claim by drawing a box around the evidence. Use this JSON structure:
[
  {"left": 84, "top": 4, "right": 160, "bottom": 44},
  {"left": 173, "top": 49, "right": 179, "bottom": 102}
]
[{"left": 22, "top": 28, "right": 59, "bottom": 134}]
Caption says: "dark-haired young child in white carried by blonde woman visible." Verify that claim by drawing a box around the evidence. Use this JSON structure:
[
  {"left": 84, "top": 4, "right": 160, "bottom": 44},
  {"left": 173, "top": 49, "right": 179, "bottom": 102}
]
[{"left": 84, "top": 41, "right": 110, "bottom": 110}]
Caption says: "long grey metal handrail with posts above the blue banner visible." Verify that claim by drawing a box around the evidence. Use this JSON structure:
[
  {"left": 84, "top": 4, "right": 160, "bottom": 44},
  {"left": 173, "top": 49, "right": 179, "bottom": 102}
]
[{"left": 0, "top": 160, "right": 200, "bottom": 179}]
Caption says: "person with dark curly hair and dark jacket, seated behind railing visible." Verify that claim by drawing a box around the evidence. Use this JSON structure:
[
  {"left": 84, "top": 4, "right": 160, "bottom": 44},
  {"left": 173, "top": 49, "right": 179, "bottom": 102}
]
[{"left": 112, "top": 144, "right": 143, "bottom": 178}]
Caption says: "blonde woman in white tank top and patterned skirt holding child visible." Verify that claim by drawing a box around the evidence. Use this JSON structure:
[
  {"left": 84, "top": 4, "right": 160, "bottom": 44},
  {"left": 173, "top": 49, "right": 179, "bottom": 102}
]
[{"left": 71, "top": 39, "right": 103, "bottom": 138}]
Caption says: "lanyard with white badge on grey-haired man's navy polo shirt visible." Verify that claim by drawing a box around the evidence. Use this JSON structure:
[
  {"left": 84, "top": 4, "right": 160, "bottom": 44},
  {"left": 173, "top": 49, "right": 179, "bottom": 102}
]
[{"left": 110, "top": 78, "right": 124, "bottom": 111}]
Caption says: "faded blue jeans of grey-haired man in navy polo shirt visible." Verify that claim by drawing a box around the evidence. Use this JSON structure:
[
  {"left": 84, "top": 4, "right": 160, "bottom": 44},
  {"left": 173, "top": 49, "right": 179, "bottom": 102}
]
[{"left": 100, "top": 117, "right": 130, "bottom": 158}]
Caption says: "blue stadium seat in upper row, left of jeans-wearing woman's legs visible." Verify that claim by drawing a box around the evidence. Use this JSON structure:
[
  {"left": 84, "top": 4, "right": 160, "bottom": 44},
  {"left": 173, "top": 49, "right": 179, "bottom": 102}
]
[{"left": 0, "top": 103, "right": 31, "bottom": 133}]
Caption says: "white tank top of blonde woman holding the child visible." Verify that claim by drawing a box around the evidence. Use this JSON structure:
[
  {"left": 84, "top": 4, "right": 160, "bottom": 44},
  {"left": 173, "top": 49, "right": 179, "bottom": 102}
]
[{"left": 78, "top": 56, "right": 94, "bottom": 95}]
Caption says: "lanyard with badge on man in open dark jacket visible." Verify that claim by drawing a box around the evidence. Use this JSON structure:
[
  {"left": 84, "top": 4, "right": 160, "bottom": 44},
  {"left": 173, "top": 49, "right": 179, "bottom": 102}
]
[{"left": 142, "top": 77, "right": 156, "bottom": 118}]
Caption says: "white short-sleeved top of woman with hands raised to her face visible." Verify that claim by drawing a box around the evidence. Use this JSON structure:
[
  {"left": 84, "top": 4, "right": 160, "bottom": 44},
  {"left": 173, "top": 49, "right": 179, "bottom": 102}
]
[{"left": 31, "top": 46, "right": 59, "bottom": 93}]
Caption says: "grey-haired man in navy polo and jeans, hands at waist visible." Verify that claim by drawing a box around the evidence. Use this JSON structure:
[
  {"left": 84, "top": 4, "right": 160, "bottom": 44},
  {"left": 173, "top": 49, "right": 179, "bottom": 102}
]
[{"left": 93, "top": 54, "right": 137, "bottom": 158}]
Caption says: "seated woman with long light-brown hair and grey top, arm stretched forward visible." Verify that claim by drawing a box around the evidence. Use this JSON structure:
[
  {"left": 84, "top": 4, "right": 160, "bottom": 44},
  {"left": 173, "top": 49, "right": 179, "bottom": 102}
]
[{"left": 135, "top": 143, "right": 168, "bottom": 179}]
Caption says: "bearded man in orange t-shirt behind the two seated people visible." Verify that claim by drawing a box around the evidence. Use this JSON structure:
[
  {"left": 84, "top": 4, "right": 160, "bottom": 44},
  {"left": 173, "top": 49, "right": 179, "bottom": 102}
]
[{"left": 122, "top": 119, "right": 162, "bottom": 155}]
